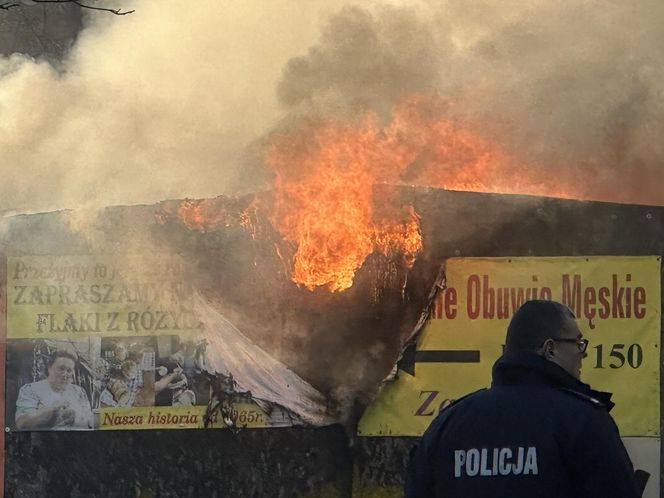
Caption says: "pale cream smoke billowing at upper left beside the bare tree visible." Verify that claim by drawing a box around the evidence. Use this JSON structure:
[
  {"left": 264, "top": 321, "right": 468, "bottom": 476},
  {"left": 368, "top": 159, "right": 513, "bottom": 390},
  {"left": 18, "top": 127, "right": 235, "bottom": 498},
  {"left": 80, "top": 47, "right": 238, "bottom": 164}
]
[{"left": 0, "top": 0, "right": 350, "bottom": 211}]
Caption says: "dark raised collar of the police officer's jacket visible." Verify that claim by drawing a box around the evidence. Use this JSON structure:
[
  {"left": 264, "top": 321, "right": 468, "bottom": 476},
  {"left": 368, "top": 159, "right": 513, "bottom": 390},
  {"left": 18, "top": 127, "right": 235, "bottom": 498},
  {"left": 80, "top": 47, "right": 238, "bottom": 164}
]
[{"left": 492, "top": 351, "right": 615, "bottom": 411}]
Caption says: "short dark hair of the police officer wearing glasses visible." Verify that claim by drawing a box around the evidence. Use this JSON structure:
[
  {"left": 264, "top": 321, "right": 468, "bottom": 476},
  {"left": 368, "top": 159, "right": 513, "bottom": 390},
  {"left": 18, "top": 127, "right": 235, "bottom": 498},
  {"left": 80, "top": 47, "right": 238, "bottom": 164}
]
[{"left": 505, "top": 300, "right": 576, "bottom": 351}]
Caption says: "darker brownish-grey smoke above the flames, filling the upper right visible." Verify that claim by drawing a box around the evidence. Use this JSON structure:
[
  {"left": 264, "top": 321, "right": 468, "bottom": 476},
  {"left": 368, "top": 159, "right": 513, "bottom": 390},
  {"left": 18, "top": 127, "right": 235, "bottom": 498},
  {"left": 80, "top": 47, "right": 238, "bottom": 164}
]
[{"left": 279, "top": 0, "right": 664, "bottom": 204}]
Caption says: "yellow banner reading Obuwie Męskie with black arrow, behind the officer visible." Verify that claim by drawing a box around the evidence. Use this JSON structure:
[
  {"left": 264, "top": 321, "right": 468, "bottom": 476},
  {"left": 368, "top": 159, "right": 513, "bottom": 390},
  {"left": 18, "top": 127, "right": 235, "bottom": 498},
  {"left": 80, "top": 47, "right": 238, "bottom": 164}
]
[{"left": 358, "top": 256, "right": 661, "bottom": 436}]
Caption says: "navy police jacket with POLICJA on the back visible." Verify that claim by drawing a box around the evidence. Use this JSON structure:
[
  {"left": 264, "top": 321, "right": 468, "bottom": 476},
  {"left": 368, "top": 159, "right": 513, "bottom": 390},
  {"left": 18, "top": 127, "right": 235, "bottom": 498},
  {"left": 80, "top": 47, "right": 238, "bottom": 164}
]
[{"left": 406, "top": 352, "right": 639, "bottom": 498}]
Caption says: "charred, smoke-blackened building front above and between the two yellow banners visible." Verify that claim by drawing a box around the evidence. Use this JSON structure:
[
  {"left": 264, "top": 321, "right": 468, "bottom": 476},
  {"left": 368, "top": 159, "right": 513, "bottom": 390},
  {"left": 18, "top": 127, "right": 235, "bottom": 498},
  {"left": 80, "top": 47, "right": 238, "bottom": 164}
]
[{"left": 0, "top": 185, "right": 664, "bottom": 426}]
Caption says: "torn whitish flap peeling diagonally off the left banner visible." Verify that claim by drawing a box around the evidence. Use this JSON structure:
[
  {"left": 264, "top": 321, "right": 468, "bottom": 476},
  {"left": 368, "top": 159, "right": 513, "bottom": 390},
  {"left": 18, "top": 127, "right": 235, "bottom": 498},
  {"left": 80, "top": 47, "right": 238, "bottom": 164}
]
[{"left": 194, "top": 295, "right": 336, "bottom": 426}]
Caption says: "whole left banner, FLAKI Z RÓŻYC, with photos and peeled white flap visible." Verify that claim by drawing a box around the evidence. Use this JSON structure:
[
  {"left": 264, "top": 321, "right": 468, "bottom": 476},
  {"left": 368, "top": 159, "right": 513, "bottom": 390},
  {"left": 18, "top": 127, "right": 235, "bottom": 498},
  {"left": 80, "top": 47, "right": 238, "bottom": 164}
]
[{"left": 3, "top": 255, "right": 324, "bottom": 431}]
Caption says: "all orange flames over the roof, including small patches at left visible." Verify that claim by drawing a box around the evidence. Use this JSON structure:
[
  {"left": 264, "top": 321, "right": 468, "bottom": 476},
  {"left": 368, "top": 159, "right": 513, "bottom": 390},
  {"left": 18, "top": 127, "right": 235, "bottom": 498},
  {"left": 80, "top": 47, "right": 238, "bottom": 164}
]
[{"left": 178, "top": 95, "right": 588, "bottom": 292}]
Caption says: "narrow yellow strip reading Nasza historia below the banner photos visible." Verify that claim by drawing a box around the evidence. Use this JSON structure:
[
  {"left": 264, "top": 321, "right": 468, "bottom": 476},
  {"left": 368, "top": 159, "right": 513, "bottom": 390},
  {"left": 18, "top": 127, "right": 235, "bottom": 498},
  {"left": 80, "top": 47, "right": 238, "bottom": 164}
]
[{"left": 95, "top": 403, "right": 266, "bottom": 430}]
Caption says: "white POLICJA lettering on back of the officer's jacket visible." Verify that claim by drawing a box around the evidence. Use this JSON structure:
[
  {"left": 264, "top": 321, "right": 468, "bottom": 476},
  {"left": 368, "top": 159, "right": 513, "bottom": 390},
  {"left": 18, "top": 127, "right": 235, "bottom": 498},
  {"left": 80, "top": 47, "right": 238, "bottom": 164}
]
[{"left": 454, "top": 446, "right": 539, "bottom": 477}]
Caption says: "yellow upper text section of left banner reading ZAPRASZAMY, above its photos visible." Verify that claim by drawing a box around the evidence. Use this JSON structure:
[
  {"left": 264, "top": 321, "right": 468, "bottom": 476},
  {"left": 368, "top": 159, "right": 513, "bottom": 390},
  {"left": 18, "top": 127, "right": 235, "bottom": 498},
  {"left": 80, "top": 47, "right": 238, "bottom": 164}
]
[{"left": 7, "top": 256, "right": 199, "bottom": 339}]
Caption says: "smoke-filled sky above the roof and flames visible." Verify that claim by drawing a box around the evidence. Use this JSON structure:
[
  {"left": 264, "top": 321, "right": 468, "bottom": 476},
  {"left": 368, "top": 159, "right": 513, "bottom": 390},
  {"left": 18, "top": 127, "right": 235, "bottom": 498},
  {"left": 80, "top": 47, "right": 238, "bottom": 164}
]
[{"left": 0, "top": 0, "right": 664, "bottom": 212}]
